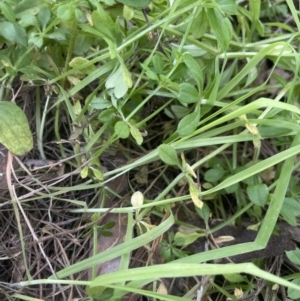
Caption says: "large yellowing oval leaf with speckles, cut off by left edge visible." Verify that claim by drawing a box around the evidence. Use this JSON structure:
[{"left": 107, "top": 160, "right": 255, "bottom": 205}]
[{"left": 0, "top": 101, "right": 33, "bottom": 156}]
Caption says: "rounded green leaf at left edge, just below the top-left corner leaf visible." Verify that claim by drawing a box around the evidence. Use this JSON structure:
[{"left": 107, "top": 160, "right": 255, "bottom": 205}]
[{"left": 0, "top": 21, "right": 27, "bottom": 46}]
